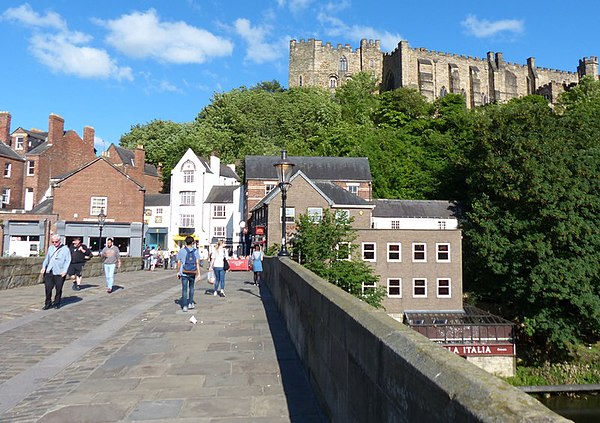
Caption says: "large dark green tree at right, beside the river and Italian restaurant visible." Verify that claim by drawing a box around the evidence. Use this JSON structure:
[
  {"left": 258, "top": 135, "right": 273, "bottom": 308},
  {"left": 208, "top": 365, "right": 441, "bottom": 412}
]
[{"left": 464, "top": 96, "right": 600, "bottom": 352}]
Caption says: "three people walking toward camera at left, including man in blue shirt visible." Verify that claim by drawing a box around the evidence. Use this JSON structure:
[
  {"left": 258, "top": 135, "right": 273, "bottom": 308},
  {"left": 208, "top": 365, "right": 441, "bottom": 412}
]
[{"left": 40, "top": 235, "right": 121, "bottom": 310}]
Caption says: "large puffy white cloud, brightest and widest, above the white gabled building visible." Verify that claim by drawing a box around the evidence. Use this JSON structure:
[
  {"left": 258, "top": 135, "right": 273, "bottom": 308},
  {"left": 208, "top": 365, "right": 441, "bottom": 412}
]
[{"left": 97, "top": 9, "right": 233, "bottom": 64}]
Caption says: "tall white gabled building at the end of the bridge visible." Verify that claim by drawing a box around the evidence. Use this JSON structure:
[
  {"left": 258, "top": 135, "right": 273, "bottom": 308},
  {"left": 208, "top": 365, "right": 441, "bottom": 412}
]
[{"left": 169, "top": 149, "right": 244, "bottom": 251}]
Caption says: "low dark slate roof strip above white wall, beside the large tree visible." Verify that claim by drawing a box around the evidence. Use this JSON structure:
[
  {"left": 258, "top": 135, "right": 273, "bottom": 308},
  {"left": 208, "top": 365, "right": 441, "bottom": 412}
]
[{"left": 373, "top": 200, "right": 460, "bottom": 219}]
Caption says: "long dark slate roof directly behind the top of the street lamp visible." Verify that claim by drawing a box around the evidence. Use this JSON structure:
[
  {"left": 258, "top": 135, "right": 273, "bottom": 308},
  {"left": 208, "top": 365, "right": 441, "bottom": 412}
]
[{"left": 245, "top": 156, "right": 372, "bottom": 181}]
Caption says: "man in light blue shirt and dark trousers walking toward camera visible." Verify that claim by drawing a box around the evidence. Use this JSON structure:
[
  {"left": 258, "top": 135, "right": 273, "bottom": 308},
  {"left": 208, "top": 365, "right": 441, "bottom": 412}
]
[{"left": 40, "top": 235, "right": 71, "bottom": 310}]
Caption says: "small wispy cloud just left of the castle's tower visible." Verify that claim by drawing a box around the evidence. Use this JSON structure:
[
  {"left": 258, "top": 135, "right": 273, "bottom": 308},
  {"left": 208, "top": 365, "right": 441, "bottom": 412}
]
[{"left": 234, "top": 19, "right": 289, "bottom": 64}]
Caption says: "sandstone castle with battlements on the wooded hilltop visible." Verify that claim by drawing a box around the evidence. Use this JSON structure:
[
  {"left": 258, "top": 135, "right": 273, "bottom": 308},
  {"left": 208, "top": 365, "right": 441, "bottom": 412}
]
[{"left": 288, "top": 39, "right": 598, "bottom": 107}]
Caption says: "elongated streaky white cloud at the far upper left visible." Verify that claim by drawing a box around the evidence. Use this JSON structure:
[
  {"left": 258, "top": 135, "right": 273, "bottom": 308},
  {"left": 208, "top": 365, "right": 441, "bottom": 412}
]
[{"left": 2, "top": 4, "right": 133, "bottom": 80}]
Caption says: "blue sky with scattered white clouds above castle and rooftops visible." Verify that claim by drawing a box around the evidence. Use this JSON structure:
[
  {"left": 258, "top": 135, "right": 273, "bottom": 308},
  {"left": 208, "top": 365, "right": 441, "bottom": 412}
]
[{"left": 0, "top": 0, "right": 600, "bottom": 150}]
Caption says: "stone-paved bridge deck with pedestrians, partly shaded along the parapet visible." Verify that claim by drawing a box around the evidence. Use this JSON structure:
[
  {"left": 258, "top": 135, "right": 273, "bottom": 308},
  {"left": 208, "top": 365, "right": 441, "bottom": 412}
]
[{"left": 0, "top": 269, "right": 325, "bottom": 423}]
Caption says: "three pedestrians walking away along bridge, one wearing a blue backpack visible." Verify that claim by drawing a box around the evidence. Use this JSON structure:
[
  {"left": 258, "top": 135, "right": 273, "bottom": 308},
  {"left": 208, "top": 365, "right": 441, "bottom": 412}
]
[{"left": 177, "top": 236, "right": 264, "bottom": 311}]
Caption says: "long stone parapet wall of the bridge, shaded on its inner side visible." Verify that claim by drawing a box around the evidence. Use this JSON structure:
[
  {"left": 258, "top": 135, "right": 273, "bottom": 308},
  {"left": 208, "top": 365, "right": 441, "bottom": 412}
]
[{"left": 263, "top": 258, "right": 569, "bottom": 422}]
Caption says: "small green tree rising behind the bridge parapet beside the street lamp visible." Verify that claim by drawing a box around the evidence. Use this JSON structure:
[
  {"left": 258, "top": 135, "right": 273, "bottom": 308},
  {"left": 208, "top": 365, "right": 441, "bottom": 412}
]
[{"left": 294, "top": 209, "right": 385, "bottom": 307}]
